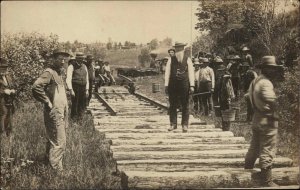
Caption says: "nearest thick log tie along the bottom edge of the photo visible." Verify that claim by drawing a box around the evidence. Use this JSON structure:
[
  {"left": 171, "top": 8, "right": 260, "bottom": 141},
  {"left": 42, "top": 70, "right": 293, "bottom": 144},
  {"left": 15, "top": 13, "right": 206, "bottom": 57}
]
[{"left": 126, "top": 167, "right": 299, "bottom": 189}]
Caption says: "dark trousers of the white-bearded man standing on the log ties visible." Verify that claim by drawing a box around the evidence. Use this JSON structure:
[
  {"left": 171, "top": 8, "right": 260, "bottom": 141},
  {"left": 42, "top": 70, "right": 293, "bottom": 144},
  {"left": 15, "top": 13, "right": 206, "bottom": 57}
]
[{"left": 168, "top": 79, "right": 190, "bottom": 125}]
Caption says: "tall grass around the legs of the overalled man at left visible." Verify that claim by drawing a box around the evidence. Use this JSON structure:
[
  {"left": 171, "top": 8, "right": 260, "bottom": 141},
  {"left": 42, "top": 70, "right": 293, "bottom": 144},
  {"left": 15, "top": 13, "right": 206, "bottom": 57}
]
[{"left": 1, "top": 102, "right": 121, "bottom": 189}]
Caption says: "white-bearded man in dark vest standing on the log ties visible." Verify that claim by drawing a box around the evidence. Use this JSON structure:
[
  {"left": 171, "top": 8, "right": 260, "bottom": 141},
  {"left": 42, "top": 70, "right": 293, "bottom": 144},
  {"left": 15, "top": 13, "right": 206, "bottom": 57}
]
[{"left": 165, "top": 43, "right": 195, "bottom": 133}]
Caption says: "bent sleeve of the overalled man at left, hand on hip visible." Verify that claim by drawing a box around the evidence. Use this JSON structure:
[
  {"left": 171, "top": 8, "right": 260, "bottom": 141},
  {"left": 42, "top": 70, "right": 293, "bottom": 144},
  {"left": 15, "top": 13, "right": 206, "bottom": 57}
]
[{"left": 32, "top": 71, "right": 52, "bottom": 104}]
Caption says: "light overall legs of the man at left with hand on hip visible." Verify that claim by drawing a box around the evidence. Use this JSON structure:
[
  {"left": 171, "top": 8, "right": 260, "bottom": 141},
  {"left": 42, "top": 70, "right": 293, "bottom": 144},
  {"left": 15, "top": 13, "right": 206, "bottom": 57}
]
[{"left": 44, "top": 107, "right": 67, "bottom": 170}]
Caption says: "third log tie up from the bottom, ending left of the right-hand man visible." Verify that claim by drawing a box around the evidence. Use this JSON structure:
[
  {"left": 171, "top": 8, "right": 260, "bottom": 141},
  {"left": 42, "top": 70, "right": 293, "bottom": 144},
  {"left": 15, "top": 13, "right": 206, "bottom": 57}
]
[{"left": 113, "top": 149, "right": 248, "bottom": 161}]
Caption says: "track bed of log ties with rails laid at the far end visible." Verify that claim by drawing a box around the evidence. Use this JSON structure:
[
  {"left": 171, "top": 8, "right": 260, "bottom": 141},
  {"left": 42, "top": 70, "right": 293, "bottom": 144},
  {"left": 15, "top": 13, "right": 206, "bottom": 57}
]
[{"left": 88, "top": 86, "right": 299, "bottom": 189}]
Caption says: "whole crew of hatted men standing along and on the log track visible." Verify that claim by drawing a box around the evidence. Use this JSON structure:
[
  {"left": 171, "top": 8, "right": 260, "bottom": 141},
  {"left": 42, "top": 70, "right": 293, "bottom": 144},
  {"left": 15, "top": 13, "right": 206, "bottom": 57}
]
[{"left": 0, "top": 40, "right": 282, "bottom": 186}]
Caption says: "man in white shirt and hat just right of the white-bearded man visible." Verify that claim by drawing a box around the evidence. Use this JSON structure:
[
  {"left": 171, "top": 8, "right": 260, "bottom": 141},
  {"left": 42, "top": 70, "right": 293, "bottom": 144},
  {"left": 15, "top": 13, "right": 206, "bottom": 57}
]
[{"left": 199, "top": 58, "right": 215, "bottom": 116}]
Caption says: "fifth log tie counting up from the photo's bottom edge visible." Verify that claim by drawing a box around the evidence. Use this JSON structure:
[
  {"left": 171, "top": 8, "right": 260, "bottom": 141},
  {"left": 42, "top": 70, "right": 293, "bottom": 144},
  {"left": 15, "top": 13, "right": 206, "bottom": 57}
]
[{"left": 112, "top": 137, "right": 246, "bottom": 146}]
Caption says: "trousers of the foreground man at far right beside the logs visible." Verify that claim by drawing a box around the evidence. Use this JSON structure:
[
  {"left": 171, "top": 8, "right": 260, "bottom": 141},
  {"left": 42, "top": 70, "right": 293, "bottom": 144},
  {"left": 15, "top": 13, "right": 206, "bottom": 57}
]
[{"left": 245, "top": 126, "right": 277, "bottom": 169}]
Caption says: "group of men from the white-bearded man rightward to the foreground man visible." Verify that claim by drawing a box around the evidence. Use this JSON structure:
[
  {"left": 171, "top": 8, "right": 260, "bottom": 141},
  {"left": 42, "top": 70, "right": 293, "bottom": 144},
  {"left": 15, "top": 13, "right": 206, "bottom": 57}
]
[{"left": 165, "top": 43, "right": 284, "bottom": 187}]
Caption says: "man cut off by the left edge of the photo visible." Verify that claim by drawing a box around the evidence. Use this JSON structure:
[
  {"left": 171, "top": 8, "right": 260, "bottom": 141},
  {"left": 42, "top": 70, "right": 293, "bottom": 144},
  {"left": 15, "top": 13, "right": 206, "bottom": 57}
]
[{"left": 0, "top": 58, "right": 16, "bottom": 136}]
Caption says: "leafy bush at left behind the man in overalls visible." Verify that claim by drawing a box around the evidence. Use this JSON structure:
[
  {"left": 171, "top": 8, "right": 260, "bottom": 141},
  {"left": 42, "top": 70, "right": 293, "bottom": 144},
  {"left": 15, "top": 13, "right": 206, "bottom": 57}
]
[{"left": 1, "top": 32, "right": 59, "bottom": 100}]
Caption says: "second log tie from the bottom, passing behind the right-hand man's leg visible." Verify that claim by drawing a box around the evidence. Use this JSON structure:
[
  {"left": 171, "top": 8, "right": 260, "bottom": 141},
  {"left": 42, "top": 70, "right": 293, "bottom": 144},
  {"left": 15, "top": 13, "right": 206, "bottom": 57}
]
[{"left": 117, "top": 157, "right": 293, "bottom": 172}]
